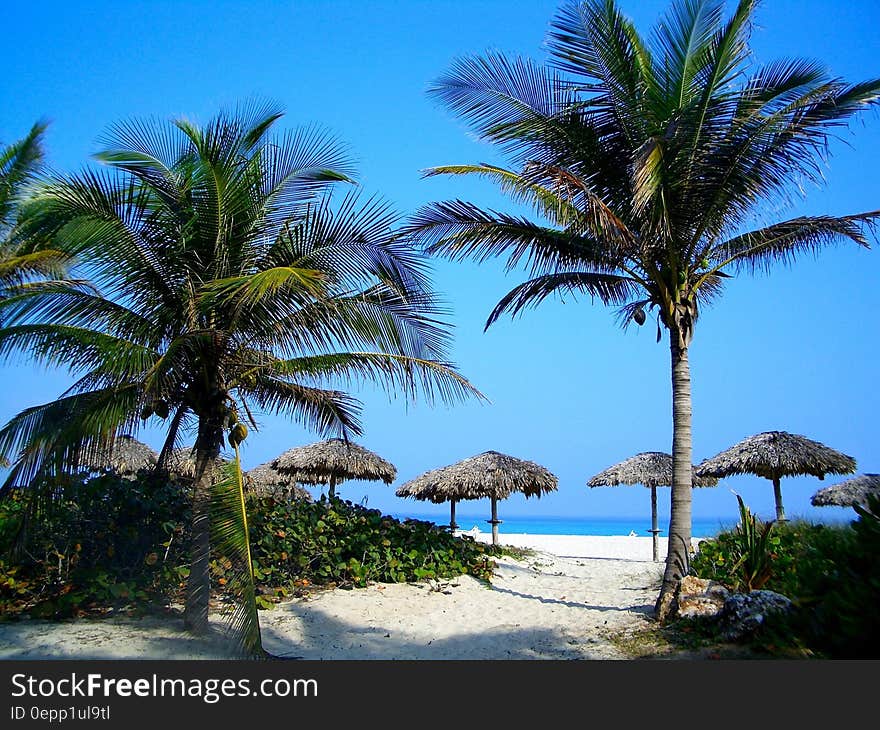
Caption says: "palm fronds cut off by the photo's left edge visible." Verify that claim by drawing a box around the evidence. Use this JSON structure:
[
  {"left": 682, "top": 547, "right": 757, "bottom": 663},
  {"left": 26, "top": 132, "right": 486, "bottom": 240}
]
[{"left": 0, "top": 122, "right": 70, "bottom": 316}]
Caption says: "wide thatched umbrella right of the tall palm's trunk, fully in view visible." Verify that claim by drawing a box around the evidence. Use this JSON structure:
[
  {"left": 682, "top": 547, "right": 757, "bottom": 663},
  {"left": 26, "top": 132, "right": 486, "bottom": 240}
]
[{"left": 696, "top": 431, "right": 856, "bottom": 522}]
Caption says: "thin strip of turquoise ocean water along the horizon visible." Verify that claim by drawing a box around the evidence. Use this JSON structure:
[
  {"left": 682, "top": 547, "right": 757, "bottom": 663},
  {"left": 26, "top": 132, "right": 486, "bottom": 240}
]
[{"left": 393, "top": 513, "right": 736, "bottom": 537}]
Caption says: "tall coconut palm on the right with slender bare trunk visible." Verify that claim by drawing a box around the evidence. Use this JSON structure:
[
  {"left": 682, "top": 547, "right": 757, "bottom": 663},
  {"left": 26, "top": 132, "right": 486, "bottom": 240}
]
[{"left": 407, "top": 0, "right": 880, "bottom": 620}]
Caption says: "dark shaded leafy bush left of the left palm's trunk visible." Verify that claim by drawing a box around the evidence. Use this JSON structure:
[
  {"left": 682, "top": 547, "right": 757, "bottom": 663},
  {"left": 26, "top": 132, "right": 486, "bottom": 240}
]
[{"left": 0, "top": 474, "right": 188, "bottom": 618}]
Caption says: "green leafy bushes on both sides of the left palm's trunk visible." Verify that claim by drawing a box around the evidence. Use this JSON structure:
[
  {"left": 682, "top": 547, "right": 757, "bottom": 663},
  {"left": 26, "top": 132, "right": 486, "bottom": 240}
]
[{"left": 0, "top": 474, "right": 500, "bottom": 617}]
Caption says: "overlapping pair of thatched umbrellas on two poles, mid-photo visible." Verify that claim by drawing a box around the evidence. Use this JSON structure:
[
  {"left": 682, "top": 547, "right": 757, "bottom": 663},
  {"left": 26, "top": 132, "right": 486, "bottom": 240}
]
[{"left": 396, "top": 451, "right": 557, "bottom": 545}]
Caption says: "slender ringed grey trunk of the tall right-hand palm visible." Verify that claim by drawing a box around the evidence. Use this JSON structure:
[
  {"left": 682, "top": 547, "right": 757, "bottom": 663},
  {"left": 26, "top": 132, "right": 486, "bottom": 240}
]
[{"left": 654, "top": 327, "right": 693, "bottom": 622}]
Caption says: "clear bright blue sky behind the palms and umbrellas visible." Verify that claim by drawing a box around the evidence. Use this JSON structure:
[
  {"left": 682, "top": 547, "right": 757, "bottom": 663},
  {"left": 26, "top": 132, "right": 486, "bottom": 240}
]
[{"left": 0, "top": 0, "right": 880, "bottom": 527}]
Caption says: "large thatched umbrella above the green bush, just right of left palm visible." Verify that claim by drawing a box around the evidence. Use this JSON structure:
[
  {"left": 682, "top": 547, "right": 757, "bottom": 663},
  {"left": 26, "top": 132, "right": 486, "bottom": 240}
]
[{"left": 270, "top": 439, "right": 397, "bottom": 497}]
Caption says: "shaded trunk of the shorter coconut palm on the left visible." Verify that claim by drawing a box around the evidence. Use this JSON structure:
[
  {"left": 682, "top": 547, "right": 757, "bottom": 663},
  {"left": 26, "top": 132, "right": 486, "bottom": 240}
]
[{"left": 184, "top": 418, "right": 223, "bottom": 634}]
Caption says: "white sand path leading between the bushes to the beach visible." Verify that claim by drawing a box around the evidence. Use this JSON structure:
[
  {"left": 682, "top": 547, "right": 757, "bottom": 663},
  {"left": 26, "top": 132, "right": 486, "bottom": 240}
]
[{"left": 0, "top": 534, "right": 692, "bottom": 659}]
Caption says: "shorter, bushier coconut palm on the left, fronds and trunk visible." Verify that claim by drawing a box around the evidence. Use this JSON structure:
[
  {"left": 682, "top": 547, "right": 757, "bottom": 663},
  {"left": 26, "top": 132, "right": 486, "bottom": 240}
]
[{"left": 0, "top": 101, "right": 479, "bottom": 651}]
